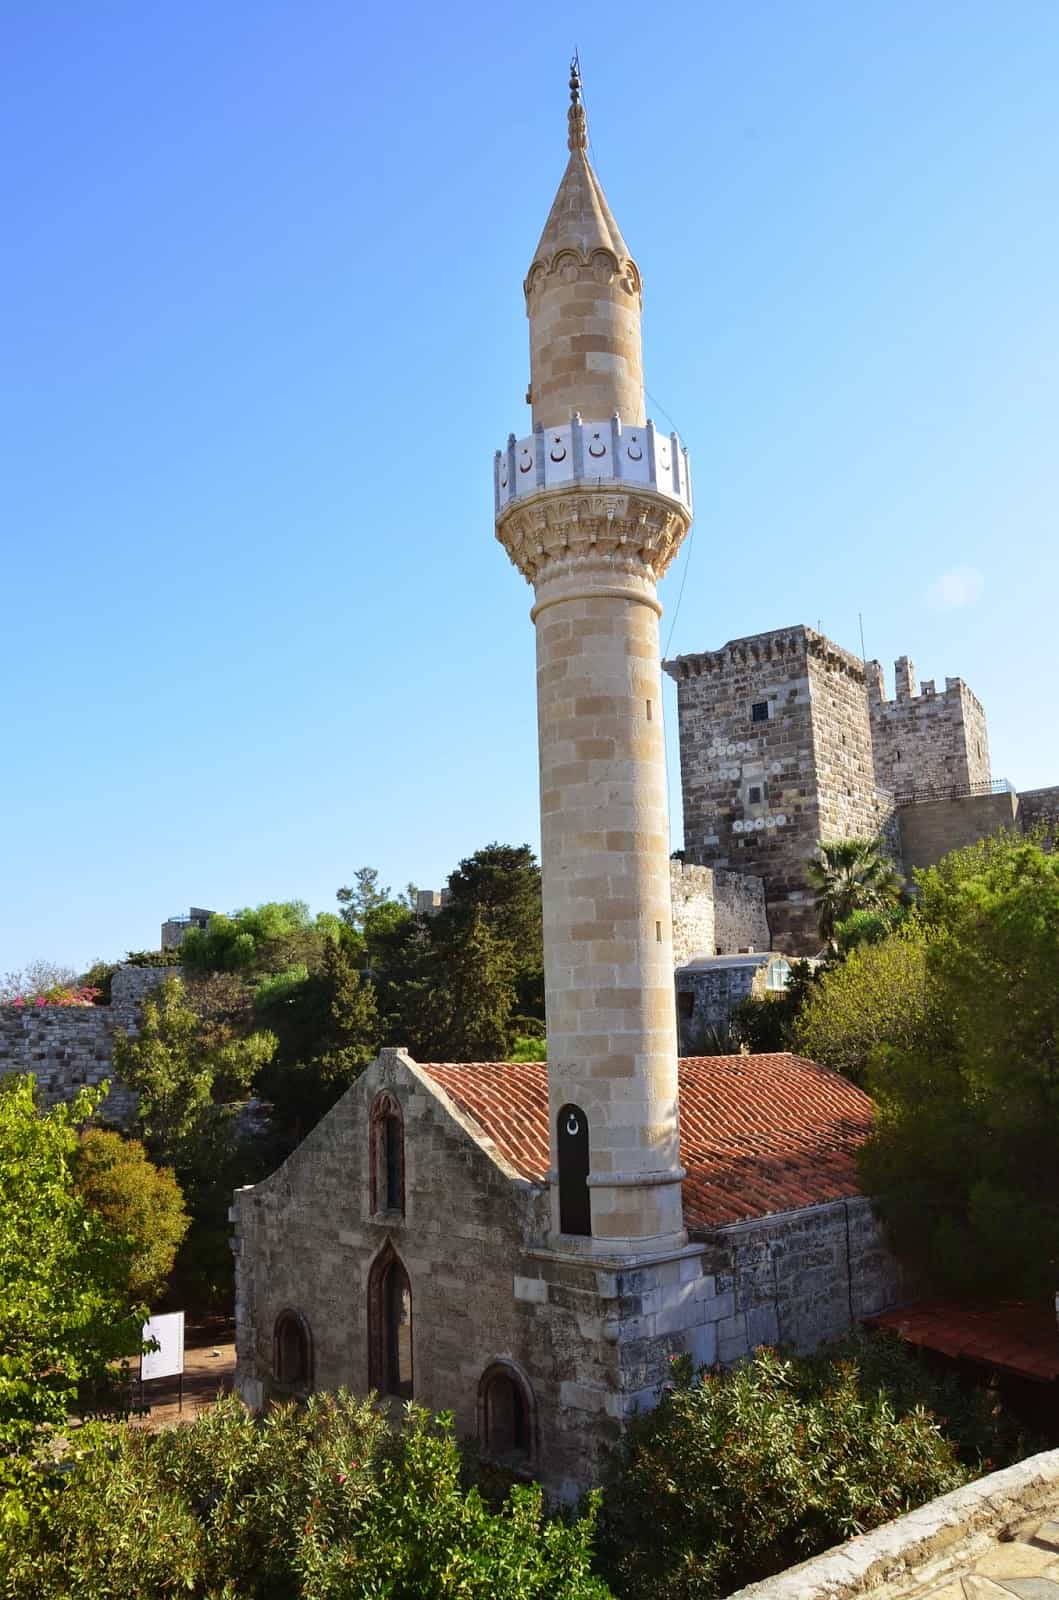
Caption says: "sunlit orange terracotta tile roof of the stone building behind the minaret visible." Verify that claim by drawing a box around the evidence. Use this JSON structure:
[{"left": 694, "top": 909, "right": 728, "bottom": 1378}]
[{"left": 419, "top": 1053, "right": 872, "bottom": 1229}]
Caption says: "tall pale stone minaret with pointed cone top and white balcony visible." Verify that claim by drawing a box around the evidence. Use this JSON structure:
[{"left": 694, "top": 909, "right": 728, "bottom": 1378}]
[{"left": 494, "top": 62, "right": 691, "bottom": 1256}]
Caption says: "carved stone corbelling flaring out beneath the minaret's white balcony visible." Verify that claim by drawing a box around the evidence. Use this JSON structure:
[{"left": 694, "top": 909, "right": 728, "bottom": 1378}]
[{"left": 496, "top": 488, "right": 691, "bottom": 584}]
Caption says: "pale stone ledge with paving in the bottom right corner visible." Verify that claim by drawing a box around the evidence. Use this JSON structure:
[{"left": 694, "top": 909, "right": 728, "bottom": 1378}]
[{"left": 728, "top": 1450, "right": 1059, "bottom": 1600}]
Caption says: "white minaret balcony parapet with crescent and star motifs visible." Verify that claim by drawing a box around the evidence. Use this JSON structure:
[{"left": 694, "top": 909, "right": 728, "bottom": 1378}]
[{"left": 493, "top": 411, "right": 691, "bottom": 518}]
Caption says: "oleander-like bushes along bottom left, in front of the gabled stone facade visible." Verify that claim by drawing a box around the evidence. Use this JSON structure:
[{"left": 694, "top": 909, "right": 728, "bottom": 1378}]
[{"left": 8, "top": 1392, "right": 608, "bottom": 1600}]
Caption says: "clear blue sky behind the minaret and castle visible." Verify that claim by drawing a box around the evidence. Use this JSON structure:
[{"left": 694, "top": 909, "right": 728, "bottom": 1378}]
[{"left": 0, "top": 0, "right": 1059, "bottom": 973}]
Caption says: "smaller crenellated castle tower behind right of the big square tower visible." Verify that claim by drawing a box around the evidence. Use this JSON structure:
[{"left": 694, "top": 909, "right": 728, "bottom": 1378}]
[{"left": 867, "top": 656, "right": 990, "bottom": 795}]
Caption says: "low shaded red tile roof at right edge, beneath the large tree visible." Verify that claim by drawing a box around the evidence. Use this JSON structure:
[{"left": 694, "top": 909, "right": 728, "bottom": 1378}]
[{"left": 865, "top": 1301, "right": 1059, "bottom": 1382}]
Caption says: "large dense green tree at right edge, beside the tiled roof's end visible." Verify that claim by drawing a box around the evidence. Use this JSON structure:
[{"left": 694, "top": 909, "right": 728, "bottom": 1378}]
[{"left": 861, "top": 837, "right": 1059, "bottom": 1298}]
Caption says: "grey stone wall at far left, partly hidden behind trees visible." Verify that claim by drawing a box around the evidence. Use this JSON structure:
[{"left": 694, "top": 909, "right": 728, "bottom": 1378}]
[{"left": 0, "top": 966, "right": 176, "bottom": 1126}]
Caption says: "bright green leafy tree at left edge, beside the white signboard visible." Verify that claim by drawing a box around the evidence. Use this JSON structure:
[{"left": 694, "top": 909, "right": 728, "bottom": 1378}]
[{"left": 0, "top": 1077, "right": 142, "bottom": 1534}]
